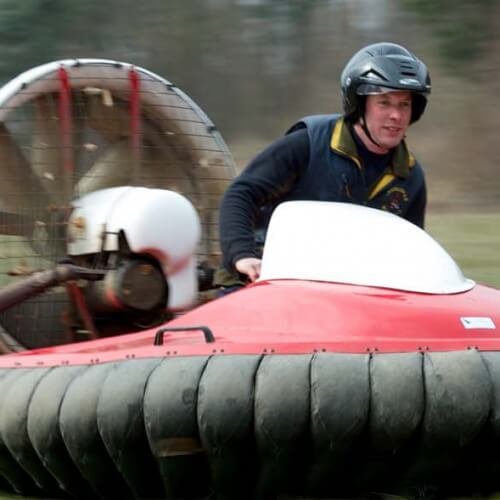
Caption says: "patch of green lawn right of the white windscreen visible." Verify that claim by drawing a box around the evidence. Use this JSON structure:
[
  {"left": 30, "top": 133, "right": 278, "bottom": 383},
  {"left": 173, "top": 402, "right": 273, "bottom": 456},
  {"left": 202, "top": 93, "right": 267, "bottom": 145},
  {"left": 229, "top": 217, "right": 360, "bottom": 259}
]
[{"left": 426, "top": 213, "right": 500, "bottom": 288}]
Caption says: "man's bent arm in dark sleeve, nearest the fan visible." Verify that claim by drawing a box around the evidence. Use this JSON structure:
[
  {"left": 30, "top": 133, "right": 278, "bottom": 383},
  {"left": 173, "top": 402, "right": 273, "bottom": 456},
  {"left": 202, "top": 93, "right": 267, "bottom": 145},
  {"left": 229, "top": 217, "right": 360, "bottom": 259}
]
[{"left": 219, "top": 129, "right": 309, "bottom": 272}]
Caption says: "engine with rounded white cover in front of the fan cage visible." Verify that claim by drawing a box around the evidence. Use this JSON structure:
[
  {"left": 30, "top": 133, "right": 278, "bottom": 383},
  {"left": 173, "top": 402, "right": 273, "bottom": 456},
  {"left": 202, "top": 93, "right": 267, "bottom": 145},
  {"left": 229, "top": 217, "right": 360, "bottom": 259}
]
[{"left": 67, "top": 186, "right": 201, "bottom": 336}]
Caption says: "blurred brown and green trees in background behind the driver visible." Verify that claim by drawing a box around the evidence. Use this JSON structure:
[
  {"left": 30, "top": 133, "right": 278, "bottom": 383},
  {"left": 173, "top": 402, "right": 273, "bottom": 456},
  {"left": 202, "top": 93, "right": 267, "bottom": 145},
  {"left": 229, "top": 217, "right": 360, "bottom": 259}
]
[{"left": 0, "top": 0, "right": 500, "bottom": 207}]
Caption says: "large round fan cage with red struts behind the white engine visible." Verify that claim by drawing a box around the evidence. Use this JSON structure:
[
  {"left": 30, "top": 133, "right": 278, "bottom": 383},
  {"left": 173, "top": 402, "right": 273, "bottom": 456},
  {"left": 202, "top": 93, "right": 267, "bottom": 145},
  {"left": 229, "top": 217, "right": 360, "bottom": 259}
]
[{"left": 0, "top": 59, "right": 235, "bottom": 350}]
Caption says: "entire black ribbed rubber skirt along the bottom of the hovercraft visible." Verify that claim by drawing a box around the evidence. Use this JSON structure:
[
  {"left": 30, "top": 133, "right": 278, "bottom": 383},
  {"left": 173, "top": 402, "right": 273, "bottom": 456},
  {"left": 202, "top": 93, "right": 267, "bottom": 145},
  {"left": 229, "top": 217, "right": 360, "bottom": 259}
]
[{"left": 0, "top": 350, "right": 500, "bottom": 500}]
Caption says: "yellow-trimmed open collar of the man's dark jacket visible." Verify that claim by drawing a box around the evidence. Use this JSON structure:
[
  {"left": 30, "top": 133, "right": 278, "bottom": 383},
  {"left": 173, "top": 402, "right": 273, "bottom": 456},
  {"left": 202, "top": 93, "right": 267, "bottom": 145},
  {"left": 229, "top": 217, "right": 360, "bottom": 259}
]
[{"left": 330, "top": 117, "right": 415, "bottom": 178}]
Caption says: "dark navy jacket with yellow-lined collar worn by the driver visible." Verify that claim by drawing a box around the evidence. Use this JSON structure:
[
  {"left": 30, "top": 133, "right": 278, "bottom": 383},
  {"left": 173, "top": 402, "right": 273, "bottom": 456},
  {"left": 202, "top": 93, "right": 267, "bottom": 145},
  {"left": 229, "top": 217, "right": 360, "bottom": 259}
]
[{"left": 219, "top": 115, "right": 426, "bottom": 270}]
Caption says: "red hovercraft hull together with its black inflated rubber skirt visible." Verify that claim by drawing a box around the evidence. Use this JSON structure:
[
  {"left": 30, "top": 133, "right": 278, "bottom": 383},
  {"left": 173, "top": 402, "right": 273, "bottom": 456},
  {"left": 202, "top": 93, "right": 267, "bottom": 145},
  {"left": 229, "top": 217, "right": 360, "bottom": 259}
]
[{"left": 0, "top": 280, "right": 500, "bottom": 498}]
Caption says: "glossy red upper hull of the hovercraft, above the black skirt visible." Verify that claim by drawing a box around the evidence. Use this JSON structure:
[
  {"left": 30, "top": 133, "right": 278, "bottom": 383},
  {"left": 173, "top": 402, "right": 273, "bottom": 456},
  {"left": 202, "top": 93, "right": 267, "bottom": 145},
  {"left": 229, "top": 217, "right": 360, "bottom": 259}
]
[{"left": 6, "top": 280, "right": 500, "bottom": 367}]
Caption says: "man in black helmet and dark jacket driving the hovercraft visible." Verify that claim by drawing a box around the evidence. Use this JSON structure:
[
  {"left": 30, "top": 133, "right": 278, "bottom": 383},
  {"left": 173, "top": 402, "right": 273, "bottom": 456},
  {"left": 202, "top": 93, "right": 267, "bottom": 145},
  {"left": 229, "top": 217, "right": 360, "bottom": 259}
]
[{"left": 216, "top": 43, "right": 431, "bottom": 286}]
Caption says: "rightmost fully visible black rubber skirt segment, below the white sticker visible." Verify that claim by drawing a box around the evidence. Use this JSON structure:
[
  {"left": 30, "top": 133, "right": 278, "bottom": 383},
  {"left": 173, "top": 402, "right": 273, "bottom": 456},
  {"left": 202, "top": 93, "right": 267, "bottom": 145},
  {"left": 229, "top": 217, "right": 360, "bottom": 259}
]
[{"left": 403, "top": 350, "right": 493, "bottom": 491}]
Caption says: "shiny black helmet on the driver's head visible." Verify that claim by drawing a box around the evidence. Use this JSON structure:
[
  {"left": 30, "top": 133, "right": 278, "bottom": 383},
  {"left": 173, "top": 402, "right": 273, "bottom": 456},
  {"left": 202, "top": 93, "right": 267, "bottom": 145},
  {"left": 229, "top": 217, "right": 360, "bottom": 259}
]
[{"left": 340, "top": 42, "right": 431, "bottom": 123}]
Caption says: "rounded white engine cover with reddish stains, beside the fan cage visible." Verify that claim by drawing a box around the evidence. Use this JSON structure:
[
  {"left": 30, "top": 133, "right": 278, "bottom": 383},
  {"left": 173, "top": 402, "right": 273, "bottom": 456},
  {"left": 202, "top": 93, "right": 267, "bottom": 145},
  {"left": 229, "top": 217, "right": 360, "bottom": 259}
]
[{"left": 68, "top": 186, "right": 201, "bottom": 311}]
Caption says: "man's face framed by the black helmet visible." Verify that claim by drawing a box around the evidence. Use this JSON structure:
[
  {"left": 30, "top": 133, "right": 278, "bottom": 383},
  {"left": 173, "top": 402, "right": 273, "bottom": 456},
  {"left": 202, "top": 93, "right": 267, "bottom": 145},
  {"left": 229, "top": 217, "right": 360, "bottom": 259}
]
[{"left": 365, "top": 92, "right": 411, "bottom": 149}]
